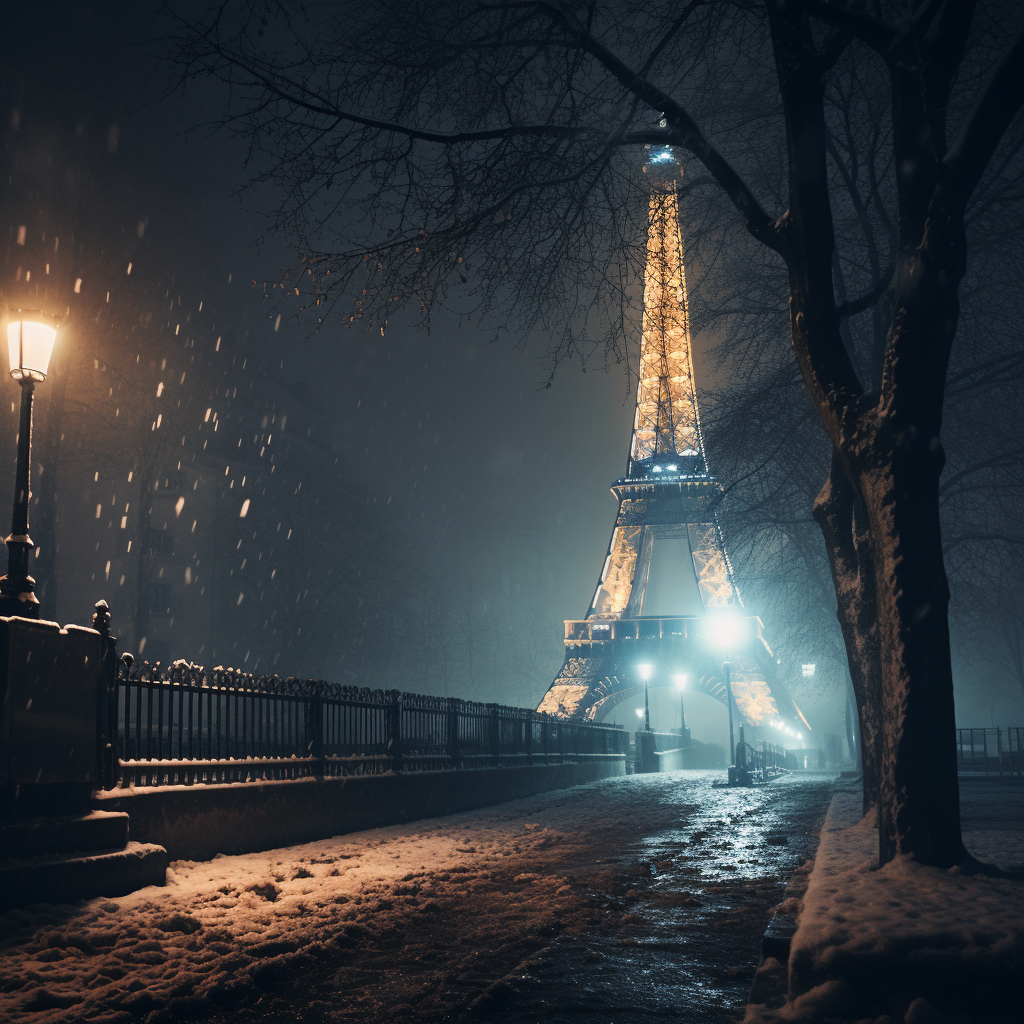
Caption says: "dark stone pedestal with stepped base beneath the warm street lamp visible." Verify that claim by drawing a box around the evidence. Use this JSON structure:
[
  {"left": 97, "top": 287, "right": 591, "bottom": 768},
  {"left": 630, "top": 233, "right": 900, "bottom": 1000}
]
[{"left": 0, "top": 616, "right": 168, "bottom": 909}]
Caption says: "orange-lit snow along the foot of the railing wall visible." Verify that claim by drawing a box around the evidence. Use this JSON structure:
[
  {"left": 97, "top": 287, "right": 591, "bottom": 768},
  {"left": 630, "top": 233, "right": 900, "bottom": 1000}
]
[{"left": 0, "top": 802, "right": 568, "bottom": 1024}]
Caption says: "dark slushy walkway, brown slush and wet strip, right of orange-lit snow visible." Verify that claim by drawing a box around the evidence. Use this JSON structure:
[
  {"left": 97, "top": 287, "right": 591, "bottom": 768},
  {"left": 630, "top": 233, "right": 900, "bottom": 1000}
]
[{"left": 188, "top": 771, "right": 835, "bottom": 1024}]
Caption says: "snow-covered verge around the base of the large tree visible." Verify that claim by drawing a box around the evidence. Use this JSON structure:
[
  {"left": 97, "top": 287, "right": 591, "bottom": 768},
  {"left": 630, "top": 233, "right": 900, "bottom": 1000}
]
[{"left": 746, "top": 786, "right": 1024, "bottom": 1022}]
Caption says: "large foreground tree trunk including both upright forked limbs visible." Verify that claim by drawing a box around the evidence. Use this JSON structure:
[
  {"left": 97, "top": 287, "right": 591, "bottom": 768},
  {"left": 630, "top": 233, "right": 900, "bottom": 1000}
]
[{"left": 768, "top": 0, "right": 968, "bottom": 867}]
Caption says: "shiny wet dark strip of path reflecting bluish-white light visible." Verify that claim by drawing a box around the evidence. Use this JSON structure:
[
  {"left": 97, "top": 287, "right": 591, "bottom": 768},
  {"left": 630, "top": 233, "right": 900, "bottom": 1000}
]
[{"left": 502, "top": 772, "right": 833, "bottom": 1024}]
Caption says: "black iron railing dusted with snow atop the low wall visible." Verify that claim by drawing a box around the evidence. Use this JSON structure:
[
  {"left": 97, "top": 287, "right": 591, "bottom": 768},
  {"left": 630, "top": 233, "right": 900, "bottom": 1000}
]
[{"left": 99, "top": 662, "right": 629, "bottom": 790}]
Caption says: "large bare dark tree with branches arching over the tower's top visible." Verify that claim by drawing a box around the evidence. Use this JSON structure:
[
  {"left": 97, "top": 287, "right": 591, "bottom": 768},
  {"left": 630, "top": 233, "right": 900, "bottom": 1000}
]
[{"left": 177, "top": 0, "right": 1024, "bottom": 865}]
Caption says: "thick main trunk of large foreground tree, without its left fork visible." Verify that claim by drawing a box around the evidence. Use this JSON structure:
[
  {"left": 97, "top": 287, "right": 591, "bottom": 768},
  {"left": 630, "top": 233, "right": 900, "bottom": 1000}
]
[{"left": 845, "top": 165, "right": 970, "bottom": 867}]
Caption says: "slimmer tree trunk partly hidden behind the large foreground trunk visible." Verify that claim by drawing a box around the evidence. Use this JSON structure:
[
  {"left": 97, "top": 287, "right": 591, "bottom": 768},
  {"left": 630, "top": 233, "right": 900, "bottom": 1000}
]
[{"left": 814, "top": 450, "right": 883, "bottom": 814}]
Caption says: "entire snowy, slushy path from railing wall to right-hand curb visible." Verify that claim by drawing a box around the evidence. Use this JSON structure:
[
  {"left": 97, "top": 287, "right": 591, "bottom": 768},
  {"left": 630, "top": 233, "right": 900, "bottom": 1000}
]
[{"left": 0, "top": 772, "right": 830, "bottom": 1024}]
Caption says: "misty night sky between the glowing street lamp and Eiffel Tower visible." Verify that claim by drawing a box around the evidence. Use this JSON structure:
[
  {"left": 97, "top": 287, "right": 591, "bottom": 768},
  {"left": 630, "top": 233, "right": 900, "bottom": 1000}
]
[{"left": 0, "top": 3, "right": 1019, "bottom": 742}]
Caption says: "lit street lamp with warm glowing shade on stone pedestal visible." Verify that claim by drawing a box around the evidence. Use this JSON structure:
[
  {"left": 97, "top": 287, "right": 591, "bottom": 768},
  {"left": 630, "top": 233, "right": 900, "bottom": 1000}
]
[{"left": 0, "top": 309, "right": 60, "bottom": 618}]
